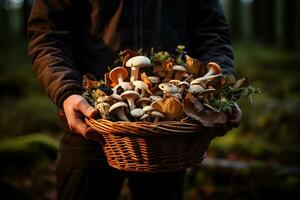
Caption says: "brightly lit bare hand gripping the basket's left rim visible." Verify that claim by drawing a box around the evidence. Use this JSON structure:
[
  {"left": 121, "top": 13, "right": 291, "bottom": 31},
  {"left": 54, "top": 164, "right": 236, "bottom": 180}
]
[{"left": 63, "top": 94, "right": 98, "bottom": 138}]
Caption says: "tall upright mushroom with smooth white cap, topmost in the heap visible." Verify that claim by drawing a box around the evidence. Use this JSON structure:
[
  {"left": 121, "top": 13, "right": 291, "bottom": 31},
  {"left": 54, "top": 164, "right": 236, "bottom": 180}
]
[{"left": 126, "top": 56, "right": 151, "bottom": 82}]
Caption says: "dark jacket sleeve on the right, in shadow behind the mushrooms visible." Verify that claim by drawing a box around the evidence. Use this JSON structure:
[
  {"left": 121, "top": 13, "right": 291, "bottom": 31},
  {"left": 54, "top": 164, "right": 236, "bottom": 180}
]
[{"left": 189, "top": 0, "right": 235, "bottom": 74}]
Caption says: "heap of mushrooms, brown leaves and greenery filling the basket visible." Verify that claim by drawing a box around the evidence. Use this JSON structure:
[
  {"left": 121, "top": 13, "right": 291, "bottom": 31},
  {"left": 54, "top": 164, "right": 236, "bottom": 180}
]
[{"left": 83, "top": 46, "right": 251, "bottom": 127}]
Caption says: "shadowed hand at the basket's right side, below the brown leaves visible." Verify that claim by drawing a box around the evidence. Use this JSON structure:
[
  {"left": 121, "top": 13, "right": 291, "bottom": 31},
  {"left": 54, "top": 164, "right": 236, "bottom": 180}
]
[{"left": 213, "top": 103, "right": 242, "bottom": 136}]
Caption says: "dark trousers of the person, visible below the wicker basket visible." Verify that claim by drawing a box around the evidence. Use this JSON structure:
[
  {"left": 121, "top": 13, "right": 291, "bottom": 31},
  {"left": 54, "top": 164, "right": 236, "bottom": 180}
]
[{"left": 56, "top": 164, "right": 184, "bottom": 200}]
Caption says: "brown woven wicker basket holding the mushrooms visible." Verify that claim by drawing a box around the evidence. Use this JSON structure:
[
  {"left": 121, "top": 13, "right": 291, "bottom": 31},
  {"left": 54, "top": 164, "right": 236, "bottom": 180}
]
[{"left": 86, "top": 119, "right": 213, "bottom": 172}]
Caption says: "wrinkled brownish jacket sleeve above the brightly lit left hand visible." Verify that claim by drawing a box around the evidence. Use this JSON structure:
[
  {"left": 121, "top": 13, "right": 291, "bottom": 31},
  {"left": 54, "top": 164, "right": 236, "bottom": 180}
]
[{"left": 28, "top": 0, "right": 81, "bottom": 108}]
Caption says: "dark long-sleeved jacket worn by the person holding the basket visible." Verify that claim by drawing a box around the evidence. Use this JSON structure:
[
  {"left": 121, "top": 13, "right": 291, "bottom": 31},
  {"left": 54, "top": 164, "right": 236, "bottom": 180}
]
[{"left": 28, "top": 0, "right": 234, "bottom": 168}]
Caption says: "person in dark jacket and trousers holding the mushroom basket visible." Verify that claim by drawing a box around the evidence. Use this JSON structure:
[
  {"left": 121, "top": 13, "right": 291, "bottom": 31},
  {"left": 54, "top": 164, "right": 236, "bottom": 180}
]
[{"left": 28, "top": 0, "right": 239, "bottom": 199}]
